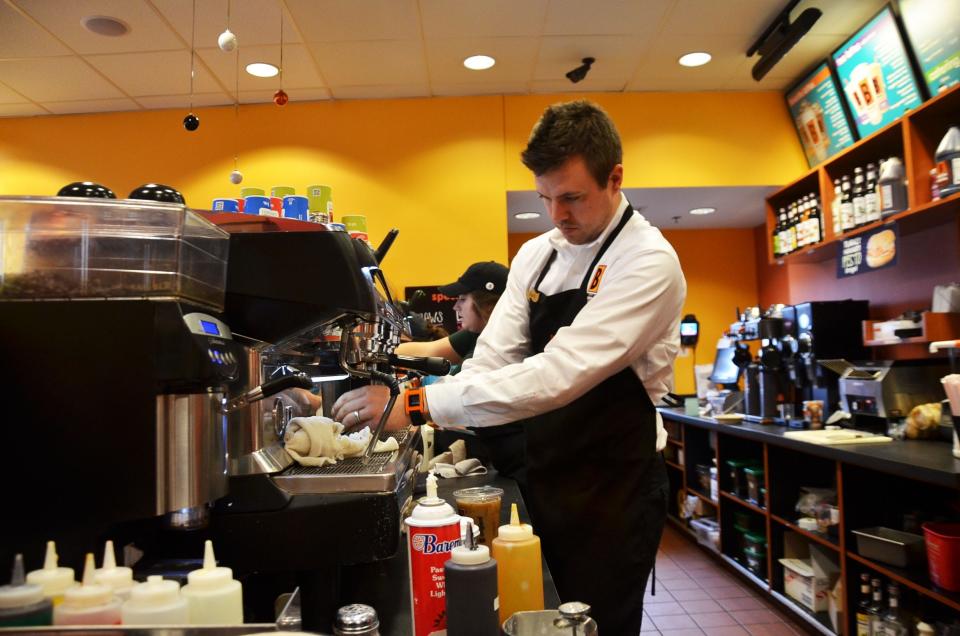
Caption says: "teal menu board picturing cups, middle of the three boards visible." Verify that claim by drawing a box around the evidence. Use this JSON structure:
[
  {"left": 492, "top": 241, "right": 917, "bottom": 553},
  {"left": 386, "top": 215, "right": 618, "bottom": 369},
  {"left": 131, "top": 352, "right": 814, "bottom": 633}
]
[{"left": 833, "top": 6, "right": 923, "bottom": 137}]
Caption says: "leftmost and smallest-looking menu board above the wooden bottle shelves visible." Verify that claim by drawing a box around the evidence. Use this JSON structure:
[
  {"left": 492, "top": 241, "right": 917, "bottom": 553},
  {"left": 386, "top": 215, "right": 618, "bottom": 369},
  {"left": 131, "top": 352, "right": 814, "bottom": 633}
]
[{"left": 787, "top": 62, "right": 854, "bottom": 167}]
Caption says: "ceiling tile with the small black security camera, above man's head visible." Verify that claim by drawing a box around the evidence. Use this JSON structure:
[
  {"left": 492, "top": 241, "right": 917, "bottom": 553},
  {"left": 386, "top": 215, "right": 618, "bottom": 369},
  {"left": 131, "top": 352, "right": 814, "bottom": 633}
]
[{"left": 534, "top": 35, "right": 651, "bottom": 82}]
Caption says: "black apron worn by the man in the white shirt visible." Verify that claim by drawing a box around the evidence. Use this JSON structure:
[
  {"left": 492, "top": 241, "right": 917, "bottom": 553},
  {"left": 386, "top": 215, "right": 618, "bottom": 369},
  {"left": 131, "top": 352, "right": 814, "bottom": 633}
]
[{"left": 524, "top": 206, "right": 669, "bottom": 636}]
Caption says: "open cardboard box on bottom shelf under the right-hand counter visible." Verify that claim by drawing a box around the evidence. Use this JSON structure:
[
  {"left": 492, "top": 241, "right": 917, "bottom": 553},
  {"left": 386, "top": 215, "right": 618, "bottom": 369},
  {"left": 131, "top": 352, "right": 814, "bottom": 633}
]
[{"left": 779, "top": 532, "right": 840, "bottom": 612}]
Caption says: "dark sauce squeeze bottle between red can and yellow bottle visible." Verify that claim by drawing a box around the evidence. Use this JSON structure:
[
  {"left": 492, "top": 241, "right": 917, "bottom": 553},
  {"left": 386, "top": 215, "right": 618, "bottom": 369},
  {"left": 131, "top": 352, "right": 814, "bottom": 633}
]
[{"left": 444, "top": 521, "right": 500, "bottom": 636}]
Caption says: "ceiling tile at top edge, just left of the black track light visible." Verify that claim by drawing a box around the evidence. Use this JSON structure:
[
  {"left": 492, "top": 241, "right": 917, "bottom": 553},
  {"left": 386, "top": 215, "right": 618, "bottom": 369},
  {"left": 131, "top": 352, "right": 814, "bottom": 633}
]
[{"left": 660, "top": 0, "right": 785, "bottom": 37}]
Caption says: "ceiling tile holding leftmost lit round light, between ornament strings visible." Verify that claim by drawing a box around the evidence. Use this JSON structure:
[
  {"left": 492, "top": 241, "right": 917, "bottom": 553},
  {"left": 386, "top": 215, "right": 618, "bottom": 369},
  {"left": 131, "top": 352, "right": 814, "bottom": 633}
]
[{"left": 198, "top": 44, "right": 325, "bottom": 92}]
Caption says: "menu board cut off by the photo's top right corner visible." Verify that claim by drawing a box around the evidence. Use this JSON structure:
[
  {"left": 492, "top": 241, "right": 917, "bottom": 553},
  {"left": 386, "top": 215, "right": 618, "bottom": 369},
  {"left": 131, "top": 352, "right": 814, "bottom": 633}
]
[{"left": 900, "top": 0, "right": 960, "bottom": 95}]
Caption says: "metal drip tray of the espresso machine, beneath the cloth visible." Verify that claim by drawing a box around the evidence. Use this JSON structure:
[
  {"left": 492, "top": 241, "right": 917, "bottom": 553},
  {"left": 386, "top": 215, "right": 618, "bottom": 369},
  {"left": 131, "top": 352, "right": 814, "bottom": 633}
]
[{"left": 272, "top": 430, "right": 420, "bottom": 495}]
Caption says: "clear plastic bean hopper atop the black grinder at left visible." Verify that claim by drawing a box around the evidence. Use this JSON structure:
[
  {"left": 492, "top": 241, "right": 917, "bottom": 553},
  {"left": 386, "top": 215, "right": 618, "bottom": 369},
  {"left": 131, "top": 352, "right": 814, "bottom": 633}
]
[{"left": 0, "top": 197, "right": 230, "bottom": 311}]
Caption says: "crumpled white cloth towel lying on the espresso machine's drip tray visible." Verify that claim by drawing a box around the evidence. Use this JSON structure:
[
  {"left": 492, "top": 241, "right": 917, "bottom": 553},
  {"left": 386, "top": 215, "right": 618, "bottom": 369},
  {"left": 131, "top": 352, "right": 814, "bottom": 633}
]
[{"left": 283, "top": 415, "right": 400, "bottom": 466}]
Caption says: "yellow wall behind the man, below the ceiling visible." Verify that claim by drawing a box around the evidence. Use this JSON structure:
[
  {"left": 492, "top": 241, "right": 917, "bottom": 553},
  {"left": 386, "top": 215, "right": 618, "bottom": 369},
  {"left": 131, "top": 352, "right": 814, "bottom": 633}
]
[{"left": 0, "top": 93, "right": 805, "bottom": 302}]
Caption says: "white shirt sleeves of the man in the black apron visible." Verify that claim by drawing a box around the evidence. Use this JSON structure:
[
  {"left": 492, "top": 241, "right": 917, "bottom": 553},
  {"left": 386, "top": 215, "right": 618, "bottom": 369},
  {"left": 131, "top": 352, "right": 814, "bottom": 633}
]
[{"left": 426, "top": 241, "right": 686, "bottom": 426}]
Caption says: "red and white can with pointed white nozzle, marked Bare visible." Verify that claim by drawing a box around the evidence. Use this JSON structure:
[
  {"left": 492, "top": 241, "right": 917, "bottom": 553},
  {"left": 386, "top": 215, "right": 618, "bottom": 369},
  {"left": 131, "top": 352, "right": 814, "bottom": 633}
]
[{"left": 404, "top": 473, "right": 460, "bottom": 636}]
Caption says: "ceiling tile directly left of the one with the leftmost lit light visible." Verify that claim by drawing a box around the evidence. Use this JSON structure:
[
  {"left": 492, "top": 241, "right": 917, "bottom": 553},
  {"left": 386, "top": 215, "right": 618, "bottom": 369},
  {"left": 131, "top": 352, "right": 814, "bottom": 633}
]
[{"left": 86, "top": 51, "right": 220, "bottom": 97}]
